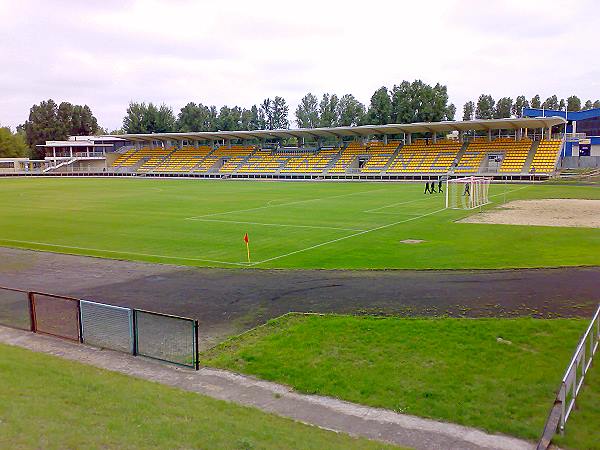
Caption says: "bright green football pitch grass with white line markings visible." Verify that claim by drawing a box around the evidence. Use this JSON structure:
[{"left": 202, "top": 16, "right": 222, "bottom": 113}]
[{"left": 0, "top": 178, "right": 600, "bottom": 269}]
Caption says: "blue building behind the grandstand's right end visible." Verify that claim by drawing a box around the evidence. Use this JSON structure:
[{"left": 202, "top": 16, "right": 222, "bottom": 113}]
[{"left": 523, "top": 108, "right": 600, "bottom": 163}]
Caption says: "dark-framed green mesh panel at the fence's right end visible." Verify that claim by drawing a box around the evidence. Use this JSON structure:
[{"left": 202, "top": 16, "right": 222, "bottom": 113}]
[{"left": 134, "top": 309, "right": 198, "bottom": 367}]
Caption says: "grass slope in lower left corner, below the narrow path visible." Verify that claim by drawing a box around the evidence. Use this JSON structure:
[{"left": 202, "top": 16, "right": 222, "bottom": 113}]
[{"left": 0, "top": 345, "right": 388, "bottom": 449}]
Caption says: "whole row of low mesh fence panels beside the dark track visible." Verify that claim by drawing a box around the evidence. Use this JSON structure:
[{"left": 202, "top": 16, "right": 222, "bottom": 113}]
[{"left": 0, "top": 287, "right": 200, "bottom": 370}]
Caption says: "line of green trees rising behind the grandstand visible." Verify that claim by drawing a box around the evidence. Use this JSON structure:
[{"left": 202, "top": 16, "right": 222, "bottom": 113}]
[{"left": 8, "top": 80, "right": 600, "bottom": 158}]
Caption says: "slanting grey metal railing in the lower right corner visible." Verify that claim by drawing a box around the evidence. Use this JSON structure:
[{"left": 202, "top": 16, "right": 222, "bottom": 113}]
[{"left": 537, "top": 305, "right": 600, "bottom": 450}]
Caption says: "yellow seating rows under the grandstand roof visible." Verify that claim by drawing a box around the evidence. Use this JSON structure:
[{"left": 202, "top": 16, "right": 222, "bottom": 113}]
[{"left": 113, "top": 138, "right": 561, "bottom": 174}]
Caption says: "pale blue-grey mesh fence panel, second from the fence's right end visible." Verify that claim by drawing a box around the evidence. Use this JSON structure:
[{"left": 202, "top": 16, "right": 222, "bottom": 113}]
[{"left": 80, "top": 300, "right": 133, "bottom": 353}]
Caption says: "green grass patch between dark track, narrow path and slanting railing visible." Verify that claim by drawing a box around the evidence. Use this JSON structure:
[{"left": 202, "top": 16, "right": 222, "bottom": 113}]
[{"left": 202, "top": 315, "right": 586, "bottom": 439}]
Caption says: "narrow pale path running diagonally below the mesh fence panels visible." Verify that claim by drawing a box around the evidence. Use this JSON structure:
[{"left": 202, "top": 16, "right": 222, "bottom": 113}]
[{"left": 0, "top": 327, "right": 533, "bottom": 450}]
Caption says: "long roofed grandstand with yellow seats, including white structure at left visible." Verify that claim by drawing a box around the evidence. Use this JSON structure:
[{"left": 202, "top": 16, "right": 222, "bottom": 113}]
[{"left": 4, "top": 116, "right": 567, "bottom": 180}]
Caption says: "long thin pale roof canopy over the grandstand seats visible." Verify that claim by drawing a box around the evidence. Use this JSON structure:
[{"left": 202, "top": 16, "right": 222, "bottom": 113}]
[{"left": 118, "top": 117, "right": 566, "bottom": 142}]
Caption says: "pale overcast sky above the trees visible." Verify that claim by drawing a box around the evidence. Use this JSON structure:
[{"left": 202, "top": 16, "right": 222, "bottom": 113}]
[{"left": 0, "top": 0, "right": 600, "bottom": 129}]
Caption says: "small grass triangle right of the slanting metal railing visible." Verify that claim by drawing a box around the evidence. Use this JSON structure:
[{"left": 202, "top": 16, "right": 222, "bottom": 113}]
[{"left": 554, "top": 362, "right": 600, "bottom": 450}]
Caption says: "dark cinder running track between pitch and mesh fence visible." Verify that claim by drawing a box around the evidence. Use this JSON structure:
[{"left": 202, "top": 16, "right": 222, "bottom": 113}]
[{"left": 0, "top": 248, "right": 600, "bottom": 349}]
